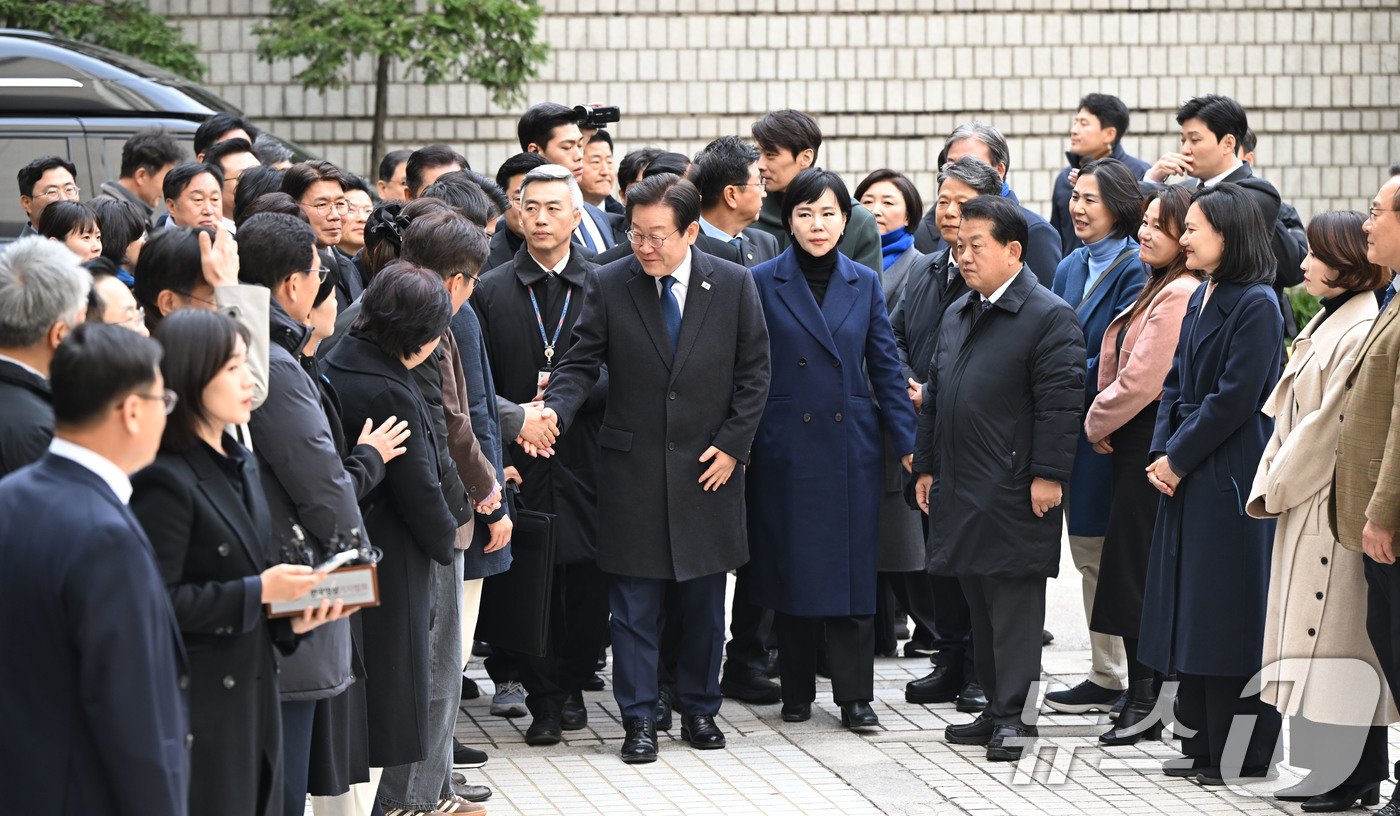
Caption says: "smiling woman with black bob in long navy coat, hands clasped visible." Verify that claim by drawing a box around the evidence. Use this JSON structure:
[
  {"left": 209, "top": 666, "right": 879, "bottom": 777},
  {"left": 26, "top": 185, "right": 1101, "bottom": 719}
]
[{"left": 1138, "top": 185, "right": 1284, "bottom": 785}]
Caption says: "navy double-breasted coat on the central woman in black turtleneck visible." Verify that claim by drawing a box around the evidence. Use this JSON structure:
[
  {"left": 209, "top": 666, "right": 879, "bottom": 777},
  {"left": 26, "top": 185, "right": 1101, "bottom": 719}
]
[{"left": 748, "top": 248, "right": 917, "bottom": 617}]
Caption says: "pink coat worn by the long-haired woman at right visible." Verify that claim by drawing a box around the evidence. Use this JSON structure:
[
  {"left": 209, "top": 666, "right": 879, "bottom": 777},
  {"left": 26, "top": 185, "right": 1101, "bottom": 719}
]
[{"left": 1084, "top": 274, "right": 1201, "bottom": 442}]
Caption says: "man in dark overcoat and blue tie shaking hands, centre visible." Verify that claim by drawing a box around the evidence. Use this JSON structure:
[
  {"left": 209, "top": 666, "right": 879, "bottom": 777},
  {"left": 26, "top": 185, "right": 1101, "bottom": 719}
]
[{"left": 545, "top": 174, "right": 769, "bottom": 763}]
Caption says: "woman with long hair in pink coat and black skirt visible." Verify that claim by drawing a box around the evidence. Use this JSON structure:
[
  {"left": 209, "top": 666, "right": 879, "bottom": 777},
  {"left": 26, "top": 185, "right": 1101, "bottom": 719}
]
[{"left": 1084, "top": 186, "right": 1201, "bottom": 745}]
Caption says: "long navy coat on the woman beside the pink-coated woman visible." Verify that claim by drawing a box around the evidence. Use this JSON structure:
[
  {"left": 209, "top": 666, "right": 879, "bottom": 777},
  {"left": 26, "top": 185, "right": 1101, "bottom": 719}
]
[{"left": 1138, "top": 283, "right": 1284, "bottom": 676}]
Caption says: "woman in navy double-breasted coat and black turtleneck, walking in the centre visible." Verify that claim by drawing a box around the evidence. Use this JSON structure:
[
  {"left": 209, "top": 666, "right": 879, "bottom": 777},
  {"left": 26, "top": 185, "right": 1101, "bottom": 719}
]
[{"left": 748, "top": 168, "right": 916, "bottom": 728}]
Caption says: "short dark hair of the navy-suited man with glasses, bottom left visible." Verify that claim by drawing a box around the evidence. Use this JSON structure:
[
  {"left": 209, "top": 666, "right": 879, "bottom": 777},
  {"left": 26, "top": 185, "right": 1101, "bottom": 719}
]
[{"left": 49, "top": 323, "right": 161, "bottom": 428}]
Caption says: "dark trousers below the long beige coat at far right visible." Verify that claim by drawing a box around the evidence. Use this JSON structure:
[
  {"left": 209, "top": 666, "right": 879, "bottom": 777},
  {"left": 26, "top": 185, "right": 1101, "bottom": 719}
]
[{"left": 1288, "top": 717, "right": 1390, "bottom": 792}]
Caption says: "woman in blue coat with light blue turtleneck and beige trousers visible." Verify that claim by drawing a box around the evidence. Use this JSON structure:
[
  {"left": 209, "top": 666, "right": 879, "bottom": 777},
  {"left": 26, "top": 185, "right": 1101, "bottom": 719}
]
[{"left": 1046, "top": 158, "right": 1144, "bottom": 714}]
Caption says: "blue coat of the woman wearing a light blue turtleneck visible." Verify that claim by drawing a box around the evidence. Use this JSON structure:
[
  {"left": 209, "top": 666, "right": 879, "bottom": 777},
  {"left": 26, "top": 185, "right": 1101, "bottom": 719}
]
[{"left": 1050, "top": 238, "right": 1147, "bottom": 536}]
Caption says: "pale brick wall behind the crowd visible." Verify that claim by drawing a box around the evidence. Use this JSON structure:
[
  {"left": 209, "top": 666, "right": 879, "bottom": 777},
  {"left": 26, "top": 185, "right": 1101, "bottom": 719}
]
[{"left": 153, "top": 0, "right": 1400, "bottom": 217}]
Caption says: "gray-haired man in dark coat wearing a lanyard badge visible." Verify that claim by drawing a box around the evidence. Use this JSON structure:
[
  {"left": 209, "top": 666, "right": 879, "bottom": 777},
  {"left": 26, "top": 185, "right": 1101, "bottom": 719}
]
[{"left": 472, "top": 164, "right": 608, "bottom": 746}]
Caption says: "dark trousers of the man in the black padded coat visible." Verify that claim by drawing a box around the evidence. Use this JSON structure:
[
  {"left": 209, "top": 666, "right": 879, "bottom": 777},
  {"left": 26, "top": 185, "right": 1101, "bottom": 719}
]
[{"left": 959, "top": 575, "right": 1046, "bottom": 725}]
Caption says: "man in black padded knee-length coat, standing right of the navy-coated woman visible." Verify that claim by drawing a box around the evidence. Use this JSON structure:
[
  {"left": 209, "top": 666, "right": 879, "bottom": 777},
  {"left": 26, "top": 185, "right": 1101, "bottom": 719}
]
[{"left": 914, "top": 196, "right": 1085, "bottom": 760}]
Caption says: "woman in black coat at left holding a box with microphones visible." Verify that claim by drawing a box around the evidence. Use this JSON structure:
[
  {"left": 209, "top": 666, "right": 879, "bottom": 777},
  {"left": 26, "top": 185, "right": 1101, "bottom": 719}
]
[{"left": 132, "top": 309, "right": 344, "bottom": 816}]
